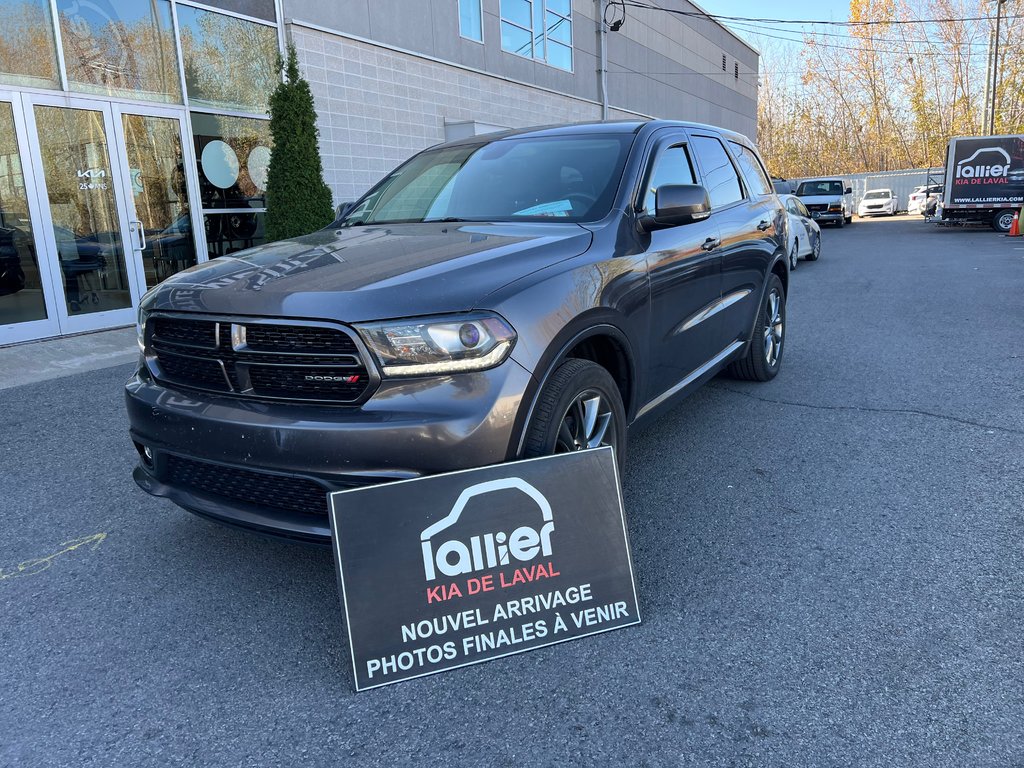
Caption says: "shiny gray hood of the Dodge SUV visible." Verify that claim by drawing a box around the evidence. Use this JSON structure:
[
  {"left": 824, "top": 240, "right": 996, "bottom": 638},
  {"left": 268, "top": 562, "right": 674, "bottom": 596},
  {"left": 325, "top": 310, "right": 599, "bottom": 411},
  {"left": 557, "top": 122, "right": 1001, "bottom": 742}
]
[{"left": 144, "top": 222, "right": 593, "bottom": 323}]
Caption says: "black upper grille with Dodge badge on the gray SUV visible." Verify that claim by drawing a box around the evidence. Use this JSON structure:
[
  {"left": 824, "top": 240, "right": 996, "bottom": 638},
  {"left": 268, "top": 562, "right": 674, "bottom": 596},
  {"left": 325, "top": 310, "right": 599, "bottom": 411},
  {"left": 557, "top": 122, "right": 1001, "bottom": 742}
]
[{"left": 146, "top": 315, "right": 373, "bottom": 404}]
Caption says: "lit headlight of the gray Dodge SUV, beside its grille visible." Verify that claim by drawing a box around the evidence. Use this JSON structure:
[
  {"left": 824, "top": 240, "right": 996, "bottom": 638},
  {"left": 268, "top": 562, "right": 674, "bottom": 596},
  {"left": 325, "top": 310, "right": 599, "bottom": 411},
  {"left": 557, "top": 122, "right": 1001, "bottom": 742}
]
[{"left": 356, "top": 312, "right": 516, "bottom": 376}]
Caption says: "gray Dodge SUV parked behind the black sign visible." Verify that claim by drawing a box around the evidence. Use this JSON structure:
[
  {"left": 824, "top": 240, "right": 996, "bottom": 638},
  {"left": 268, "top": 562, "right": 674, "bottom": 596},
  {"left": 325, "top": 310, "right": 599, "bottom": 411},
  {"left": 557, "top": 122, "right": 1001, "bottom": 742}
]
[{"left": 126, "top": 121, "right": 788, "bottom": 542}]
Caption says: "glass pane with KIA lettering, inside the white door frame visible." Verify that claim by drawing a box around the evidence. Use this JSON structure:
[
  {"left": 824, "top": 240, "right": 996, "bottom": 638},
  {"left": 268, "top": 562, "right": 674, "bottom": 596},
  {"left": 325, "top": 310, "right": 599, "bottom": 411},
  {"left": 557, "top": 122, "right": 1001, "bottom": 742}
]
[{"left": 35, "top": 105, "right": 131, "bottom": 314}]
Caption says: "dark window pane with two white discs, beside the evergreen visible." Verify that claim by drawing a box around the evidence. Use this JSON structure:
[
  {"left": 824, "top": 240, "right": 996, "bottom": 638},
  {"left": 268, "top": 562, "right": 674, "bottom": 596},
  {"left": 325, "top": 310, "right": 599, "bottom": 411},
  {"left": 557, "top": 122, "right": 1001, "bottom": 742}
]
[{"left": 191, "top": 112, "right": 271, "bottom": 208}]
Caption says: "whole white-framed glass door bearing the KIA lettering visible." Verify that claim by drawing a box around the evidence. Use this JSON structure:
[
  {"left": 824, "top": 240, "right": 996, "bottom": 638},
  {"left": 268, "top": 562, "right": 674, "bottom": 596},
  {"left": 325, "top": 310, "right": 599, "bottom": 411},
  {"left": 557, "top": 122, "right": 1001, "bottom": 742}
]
[{"left": 26, "top": 94, "right": 141, "bottom": 333}]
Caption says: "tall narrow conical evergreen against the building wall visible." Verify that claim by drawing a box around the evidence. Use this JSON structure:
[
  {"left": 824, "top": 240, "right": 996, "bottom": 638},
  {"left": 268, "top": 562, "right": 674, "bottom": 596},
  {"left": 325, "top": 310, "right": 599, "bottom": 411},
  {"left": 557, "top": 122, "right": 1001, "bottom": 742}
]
[{"left": 266, "top": 45, "right": 334, "bottom": 242}]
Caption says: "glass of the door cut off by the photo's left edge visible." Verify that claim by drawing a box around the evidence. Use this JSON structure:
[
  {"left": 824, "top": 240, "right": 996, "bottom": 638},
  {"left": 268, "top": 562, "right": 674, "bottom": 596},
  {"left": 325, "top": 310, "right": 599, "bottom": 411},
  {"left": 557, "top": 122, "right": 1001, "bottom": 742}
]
[{"left": 0, "top": 101, "right": 46, "bottom": 326}]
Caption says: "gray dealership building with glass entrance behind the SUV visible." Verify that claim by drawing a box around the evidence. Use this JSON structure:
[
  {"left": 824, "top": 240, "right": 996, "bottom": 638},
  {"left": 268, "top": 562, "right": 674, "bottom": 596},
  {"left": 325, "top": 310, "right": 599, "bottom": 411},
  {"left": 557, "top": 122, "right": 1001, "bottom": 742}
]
[{"left": 0, "top": 0, "right": 758, "bottom": 345}]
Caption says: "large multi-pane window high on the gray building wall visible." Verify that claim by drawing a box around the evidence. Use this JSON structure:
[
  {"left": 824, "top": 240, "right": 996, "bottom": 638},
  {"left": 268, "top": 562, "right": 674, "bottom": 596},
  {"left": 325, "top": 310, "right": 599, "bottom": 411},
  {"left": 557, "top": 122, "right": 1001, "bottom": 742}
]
[{"left": 501, "top": 0, "right": 572, "bottom": 72}]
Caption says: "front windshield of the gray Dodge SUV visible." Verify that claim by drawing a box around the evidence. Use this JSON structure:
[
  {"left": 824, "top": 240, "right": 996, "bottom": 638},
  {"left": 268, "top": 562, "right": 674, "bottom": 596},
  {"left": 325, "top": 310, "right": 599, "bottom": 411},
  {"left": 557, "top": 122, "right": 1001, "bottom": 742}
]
[{"left": 342, "top": 134, "right": 633, "bottom": 226}]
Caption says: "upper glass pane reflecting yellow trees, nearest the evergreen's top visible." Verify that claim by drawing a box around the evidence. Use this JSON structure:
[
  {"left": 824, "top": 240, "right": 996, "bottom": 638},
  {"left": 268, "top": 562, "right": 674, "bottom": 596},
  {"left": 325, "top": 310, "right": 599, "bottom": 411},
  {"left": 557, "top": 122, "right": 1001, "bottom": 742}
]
[{"left": 178, "top": 5, "right": 281, "bottom": 113}]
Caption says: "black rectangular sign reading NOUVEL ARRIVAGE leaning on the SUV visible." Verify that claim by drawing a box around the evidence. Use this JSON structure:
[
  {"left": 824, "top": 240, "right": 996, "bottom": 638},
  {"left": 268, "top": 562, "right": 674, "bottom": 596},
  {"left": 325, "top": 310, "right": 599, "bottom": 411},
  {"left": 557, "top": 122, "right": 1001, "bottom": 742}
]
[{"left": 331, "top": 449, "right": 640, "bottom": 690}]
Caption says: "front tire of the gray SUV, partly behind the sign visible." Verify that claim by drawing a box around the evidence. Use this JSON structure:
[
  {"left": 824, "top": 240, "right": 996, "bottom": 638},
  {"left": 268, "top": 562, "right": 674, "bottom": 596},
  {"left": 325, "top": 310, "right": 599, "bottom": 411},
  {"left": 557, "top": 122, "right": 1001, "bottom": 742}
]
[{"left": 523, "top": 358, "right": 626, "bottom": 469}]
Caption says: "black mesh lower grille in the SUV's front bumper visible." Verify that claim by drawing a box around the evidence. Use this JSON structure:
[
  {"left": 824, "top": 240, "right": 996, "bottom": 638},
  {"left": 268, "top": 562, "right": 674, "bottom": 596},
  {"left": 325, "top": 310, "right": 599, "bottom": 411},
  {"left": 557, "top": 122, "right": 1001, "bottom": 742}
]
[{"left": 165, "top": 454, "right": 328, "bottom": 517}]
